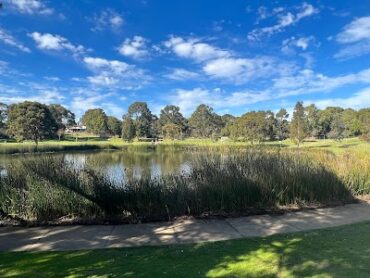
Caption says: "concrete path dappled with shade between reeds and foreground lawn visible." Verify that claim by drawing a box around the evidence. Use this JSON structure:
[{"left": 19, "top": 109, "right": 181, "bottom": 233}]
[{"left": 0, "top": 202, "right": 370, "bottom": 251}]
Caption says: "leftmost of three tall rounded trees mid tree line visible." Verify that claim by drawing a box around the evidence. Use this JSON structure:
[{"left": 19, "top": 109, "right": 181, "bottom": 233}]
[{"left": 127, "top": 102, "right": 152, "bottom": 137}]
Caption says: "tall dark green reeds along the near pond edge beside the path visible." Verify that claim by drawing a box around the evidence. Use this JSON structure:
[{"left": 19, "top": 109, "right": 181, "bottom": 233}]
[{"left": 0, "top": 150, "right": 362, "bottom": 222}]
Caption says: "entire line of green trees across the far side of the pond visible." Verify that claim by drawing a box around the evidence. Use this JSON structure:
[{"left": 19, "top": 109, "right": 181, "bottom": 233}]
[{"left": 0, "top": 101, "right": 370, "bottom": 145}]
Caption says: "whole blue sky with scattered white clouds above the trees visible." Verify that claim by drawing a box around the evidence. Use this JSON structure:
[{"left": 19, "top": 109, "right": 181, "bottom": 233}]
[{"left": 0, "top": 0, "right": 370, "bottom": 118}]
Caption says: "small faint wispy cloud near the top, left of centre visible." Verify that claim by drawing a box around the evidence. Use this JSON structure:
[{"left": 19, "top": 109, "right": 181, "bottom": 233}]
[{"left": 90, "top": 9, "right": 125, "bottom": 31}]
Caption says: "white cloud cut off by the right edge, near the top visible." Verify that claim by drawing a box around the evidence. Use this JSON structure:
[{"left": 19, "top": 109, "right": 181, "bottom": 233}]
[{"left": 334, "top": 16, "right": 370, "bottom": 59}]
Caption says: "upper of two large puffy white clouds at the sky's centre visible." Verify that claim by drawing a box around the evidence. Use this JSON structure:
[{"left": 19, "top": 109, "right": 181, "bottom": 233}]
[{"left": 164, "top": 37, "right": 231, "bottom": 62}]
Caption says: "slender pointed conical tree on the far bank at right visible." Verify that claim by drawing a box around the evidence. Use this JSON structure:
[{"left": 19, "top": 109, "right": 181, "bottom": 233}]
[{"left": 289, "top": 102, "right": 308, "bottom": 147}]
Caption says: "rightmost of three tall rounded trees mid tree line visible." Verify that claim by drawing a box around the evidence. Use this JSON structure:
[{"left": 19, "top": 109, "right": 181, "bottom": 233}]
[{"left": 189, "top": 104, "right": 223, "bottom": 137}]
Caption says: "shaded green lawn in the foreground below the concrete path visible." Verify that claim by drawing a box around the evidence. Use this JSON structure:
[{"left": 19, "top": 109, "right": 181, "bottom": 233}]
[{"left": 0, "top": 222, "right": 370, "bottom": 277}]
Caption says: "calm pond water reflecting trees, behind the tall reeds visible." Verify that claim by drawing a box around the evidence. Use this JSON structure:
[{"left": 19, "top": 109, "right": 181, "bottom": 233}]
[{"left": 0, "top": 149, "right": 197, "bottom": 181}]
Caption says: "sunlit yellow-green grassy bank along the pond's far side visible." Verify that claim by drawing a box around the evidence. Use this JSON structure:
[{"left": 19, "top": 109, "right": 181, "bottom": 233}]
[{"left": 0, "top": 137, "right": 370, "bottom": 154}]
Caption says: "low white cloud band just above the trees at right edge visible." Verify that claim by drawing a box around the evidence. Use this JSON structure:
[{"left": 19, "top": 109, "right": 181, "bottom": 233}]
[{"left": 305, "top": 88, "right": 370, "bottom": 109}]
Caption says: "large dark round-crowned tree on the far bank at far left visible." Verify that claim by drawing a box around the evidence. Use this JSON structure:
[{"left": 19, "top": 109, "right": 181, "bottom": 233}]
[{"left": 8, "top": 101, "right": 57, "bottom": 145}]
